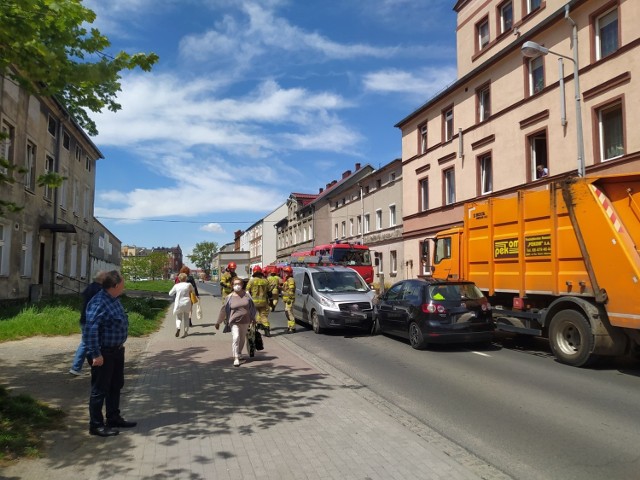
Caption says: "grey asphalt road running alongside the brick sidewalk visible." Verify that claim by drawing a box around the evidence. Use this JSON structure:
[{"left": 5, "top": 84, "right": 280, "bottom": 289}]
[{"left": 199, "top": 282, "right": 640, "bottom": 480}]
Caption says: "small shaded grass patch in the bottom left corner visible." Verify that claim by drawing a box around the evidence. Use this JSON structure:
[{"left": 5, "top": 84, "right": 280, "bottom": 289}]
[{"left": 0, "top": 385, "right": 65, "bottom": 465}]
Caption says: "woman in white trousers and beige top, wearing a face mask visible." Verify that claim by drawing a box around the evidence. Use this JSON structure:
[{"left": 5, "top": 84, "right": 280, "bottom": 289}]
[{"left": 215, "top": 277, "right": 256, "bottom": 367}]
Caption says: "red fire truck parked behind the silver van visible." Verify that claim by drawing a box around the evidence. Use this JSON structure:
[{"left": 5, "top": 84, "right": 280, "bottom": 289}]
[{"left": 289, "top": 243, "right": 373, "bottom": 284}]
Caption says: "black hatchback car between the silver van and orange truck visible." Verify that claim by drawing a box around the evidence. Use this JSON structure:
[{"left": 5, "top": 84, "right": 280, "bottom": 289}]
[{"left": 373, "top": 279, "right": 494, "bottom": 349}]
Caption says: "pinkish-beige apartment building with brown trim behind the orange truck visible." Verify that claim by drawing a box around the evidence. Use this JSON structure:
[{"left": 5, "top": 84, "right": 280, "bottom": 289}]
[{"left": 396, "top": 0, "right": 640, "bottom": 274}]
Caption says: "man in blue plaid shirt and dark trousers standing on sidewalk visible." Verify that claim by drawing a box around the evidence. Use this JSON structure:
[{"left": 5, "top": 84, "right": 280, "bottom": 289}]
[{"left": 83, "top": 270, "right": 137, "bottom": 437}]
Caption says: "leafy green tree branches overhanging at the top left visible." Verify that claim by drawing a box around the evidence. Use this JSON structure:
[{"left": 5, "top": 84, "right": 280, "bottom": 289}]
[{"left": 0, "top": 0, "right": 158, "bottom": 214}]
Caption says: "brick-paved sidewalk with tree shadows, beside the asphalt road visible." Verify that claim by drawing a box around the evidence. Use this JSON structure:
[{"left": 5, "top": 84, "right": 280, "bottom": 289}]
[{"left": 3, "top": 295, "right": 508, "bottom": 480}]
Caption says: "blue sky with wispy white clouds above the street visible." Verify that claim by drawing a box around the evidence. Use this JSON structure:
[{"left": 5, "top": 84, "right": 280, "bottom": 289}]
[{"left": 84, "top": 0, "right": 456, "bottom": 264}]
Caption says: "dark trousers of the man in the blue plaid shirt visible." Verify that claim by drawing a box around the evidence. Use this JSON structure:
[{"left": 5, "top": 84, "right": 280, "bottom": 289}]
[{"left": 89, "top": 347, "right": 124, "bottom": 428}]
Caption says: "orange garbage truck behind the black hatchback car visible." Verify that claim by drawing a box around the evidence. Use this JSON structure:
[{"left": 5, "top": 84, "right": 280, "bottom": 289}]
[{"left": 425, "top": 173, "right": 640, "bottom": 366}]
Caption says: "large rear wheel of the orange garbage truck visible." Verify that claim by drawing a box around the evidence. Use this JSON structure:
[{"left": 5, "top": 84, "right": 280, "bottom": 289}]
[{"left": 549, "top": 310, "right": 596, "bottom": 367}]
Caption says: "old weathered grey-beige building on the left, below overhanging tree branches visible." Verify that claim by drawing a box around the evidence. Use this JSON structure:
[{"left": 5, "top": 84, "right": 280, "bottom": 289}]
[{"left": 0, "top": 77, "right": 103, "bottom": 300}]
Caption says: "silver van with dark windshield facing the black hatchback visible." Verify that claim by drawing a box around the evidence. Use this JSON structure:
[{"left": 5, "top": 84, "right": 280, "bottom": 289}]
[{"left": 292, "top": 266, "right": 375, "bottom": 333}]
